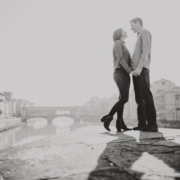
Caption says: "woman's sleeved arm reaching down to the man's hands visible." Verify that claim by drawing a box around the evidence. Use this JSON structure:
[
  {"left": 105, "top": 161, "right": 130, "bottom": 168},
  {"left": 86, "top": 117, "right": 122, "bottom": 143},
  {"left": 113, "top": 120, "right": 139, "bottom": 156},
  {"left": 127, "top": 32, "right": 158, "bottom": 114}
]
[{"left": 114, "top": 41, "right": 132, "bottom": 74}]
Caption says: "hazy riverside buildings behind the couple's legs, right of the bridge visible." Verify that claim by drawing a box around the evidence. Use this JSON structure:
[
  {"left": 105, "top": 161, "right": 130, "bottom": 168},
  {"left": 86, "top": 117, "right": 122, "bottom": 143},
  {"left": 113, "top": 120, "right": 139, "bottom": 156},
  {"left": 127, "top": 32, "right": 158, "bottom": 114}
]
[{"left": 85, "top": 79, "right": 180, "bottom": 125}]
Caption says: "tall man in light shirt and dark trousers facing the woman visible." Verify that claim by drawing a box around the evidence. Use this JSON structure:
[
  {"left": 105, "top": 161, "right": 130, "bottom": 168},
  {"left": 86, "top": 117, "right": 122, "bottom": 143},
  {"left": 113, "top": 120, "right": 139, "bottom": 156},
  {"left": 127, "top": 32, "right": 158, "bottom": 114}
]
[{"left": 130, "top": 18, "right": 158, "bottom": 132}]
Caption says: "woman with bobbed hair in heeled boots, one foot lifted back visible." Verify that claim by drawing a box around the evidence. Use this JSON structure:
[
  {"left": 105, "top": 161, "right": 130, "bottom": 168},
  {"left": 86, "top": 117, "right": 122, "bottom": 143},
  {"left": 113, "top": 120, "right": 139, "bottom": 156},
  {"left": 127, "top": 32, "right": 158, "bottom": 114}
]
[{"left": 101, "top": 28, "right": 133, "bottom": 132}]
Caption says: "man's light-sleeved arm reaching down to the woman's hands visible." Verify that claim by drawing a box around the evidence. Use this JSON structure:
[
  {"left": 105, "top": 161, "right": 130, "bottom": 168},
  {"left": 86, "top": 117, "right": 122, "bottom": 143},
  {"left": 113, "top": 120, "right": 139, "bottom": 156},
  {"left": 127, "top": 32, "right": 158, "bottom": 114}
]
[{"left": 134, "top": 30, "right": 151, "bottom": 75}]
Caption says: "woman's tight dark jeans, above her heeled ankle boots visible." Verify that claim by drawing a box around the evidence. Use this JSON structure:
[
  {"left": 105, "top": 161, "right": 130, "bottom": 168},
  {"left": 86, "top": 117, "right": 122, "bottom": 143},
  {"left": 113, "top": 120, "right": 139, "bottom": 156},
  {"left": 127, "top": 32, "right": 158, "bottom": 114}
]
[{"left": 109, "top": 68, "right": 130, "bottom": 119}]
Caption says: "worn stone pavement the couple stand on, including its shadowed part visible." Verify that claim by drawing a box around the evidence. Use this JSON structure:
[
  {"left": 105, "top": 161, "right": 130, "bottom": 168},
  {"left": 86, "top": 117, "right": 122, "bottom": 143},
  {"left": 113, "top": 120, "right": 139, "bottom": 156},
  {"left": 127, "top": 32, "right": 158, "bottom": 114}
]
[{"left": 0, "top": 126, "right": 180, "bottom": 180}]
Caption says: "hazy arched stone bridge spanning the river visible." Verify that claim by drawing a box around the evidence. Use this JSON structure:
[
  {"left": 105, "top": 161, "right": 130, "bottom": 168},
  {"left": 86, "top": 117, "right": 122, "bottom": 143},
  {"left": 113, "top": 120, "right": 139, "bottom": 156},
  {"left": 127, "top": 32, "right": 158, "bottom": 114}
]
[{"left": 22, "top": 106, "right": 102, "bottom": 123}]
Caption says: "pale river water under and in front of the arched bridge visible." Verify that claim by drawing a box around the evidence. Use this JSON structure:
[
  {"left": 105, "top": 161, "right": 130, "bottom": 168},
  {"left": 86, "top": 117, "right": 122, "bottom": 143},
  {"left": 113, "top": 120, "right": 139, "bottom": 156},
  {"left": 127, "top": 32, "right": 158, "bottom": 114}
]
[{"left": 0, "top": 117, "right": 88, "bottom": 150}]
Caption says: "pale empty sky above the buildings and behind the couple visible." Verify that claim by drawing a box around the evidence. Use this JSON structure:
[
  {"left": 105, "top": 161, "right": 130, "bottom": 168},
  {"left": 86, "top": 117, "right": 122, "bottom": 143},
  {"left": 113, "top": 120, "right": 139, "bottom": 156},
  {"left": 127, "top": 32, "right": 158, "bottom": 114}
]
[{"left": 0, "top": 0, "right": 180, "bottom": 106}]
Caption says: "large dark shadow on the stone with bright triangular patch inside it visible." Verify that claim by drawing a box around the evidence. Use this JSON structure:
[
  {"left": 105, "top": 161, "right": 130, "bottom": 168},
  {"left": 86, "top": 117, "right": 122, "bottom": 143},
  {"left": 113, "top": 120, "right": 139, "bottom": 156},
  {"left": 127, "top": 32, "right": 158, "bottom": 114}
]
[{"left": 88, "top": 131, "right": 180, "bottom": 180}]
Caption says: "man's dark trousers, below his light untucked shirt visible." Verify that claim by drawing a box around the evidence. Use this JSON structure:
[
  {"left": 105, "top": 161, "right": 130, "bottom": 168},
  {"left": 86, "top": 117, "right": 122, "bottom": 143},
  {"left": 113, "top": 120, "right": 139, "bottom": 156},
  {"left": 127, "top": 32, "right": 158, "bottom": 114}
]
[{"left": 133, "top": 68, "right": 157, "bottom": 126}]
